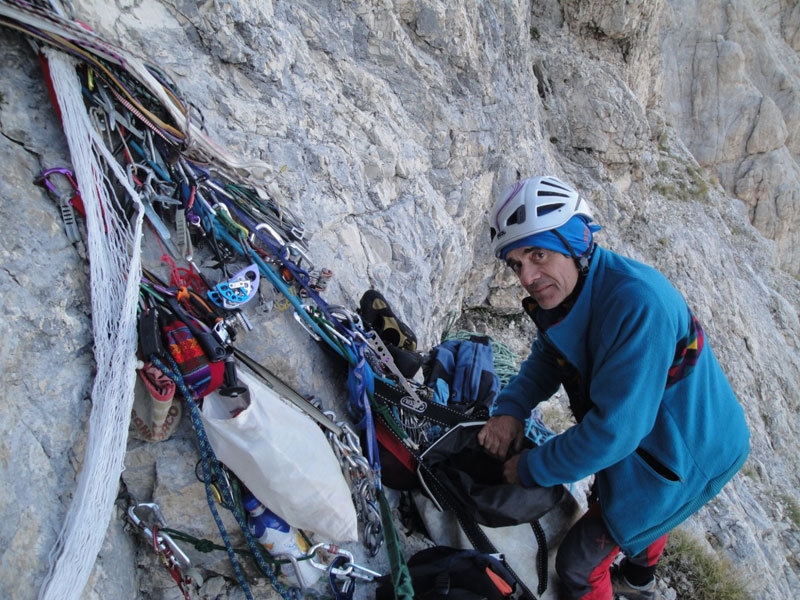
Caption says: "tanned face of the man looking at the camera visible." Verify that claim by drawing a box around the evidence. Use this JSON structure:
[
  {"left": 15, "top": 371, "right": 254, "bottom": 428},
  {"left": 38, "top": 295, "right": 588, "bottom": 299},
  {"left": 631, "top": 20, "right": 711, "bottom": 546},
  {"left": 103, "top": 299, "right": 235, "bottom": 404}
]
[{"left": 506, "top": 246, "right": 578, "bottom": 310}]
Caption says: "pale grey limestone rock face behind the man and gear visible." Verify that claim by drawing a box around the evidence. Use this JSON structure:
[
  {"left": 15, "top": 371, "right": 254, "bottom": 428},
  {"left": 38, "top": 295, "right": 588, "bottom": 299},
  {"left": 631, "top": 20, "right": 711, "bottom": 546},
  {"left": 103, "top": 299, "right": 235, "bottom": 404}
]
[{"left": 0, "top": 0, "right": 800, "bottom": 600}]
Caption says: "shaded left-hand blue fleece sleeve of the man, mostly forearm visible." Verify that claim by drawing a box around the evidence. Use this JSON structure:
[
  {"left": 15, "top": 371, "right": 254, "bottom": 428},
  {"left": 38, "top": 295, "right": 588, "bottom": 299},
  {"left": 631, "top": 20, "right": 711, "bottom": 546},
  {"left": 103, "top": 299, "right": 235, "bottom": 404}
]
[{"left": 491, "top": 337, "right": 561, "bottom": 422}]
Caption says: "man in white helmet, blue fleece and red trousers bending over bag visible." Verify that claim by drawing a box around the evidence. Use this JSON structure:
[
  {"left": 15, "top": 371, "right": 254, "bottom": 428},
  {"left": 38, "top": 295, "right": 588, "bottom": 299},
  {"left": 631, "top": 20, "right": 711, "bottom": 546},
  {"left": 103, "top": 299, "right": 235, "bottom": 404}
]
[{"left": 478, "top": 177, "right": 749, "bottom": 600}]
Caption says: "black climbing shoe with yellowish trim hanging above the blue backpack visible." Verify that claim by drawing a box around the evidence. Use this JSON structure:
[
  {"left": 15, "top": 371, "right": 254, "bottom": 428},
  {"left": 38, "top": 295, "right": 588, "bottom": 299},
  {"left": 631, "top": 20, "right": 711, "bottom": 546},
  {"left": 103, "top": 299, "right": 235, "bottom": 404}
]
[{"left": 358, "top": 290, "right": 422, "bottom": 379}]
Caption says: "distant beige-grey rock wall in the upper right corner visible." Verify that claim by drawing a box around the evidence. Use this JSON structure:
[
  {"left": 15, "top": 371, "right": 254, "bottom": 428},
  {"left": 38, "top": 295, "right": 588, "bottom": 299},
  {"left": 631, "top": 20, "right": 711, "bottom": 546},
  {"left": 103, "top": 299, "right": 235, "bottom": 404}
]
[{"left": 662, "top": 1, "right": 800, "bottom": 275}]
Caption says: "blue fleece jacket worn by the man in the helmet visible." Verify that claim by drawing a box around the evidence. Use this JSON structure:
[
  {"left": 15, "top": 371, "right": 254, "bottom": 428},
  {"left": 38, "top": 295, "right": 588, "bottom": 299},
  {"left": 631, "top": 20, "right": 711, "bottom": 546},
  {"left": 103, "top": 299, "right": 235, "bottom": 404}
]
[{"left": 492, "top": 247, "right": 749, "bottom": 554}]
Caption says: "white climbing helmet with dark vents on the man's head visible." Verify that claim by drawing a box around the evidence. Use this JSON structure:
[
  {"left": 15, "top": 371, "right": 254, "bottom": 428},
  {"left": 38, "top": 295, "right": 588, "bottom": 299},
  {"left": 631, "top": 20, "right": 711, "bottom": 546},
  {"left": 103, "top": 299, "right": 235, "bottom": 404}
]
[{"left": 489, "top": 176, "right": 592, "bottom": 258}]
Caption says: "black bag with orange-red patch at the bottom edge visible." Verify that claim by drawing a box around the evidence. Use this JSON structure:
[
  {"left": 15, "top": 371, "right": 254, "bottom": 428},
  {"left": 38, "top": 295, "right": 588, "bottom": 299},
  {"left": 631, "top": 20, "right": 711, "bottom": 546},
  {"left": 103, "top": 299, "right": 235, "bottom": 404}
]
[{"left": 375, "top": 546, "right": 516, "bottom": 600}]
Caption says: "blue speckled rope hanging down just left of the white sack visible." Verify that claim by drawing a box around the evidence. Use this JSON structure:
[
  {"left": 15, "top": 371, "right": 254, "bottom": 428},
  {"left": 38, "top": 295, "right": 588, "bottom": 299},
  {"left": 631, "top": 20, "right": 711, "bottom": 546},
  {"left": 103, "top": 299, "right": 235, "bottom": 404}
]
[{"left": 151, "top": 355, "right": 303, "bottom": 600}]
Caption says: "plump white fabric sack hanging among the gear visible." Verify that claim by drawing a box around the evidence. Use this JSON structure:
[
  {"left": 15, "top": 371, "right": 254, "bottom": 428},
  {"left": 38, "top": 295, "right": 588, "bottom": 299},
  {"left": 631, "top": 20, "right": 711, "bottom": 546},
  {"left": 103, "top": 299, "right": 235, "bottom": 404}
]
[{"left": 201, "top": 369, "right": 358, "bottom": 542}]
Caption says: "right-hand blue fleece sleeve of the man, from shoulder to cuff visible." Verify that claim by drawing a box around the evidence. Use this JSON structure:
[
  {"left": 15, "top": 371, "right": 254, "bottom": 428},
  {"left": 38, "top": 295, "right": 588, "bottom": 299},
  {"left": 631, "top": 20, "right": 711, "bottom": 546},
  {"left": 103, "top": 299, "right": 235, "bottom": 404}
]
[{"left": 519, "top": 285, "right": 683, "bottom": 486}]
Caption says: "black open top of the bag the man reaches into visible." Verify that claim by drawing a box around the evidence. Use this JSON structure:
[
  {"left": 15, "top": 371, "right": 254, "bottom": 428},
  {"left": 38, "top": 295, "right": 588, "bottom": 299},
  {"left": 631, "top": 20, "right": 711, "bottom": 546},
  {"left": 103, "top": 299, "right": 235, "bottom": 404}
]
[{"left": 418, "top": 421, "right": 566, "bottom": 527}]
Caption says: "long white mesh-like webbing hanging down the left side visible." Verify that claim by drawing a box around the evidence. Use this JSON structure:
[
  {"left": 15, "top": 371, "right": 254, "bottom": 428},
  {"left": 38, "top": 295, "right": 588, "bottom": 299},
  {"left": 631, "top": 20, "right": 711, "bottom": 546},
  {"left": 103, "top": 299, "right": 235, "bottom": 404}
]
[{"left": 39, "top": 51, "right": 144, "bottom": 600}]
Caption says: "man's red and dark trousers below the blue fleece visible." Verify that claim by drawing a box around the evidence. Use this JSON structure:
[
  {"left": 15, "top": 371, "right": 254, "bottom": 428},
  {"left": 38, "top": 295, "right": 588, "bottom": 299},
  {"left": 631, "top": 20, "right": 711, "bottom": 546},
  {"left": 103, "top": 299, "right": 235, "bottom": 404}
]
[{"left": 556, "top": 502, "right": 667, "bottom": 600}]
